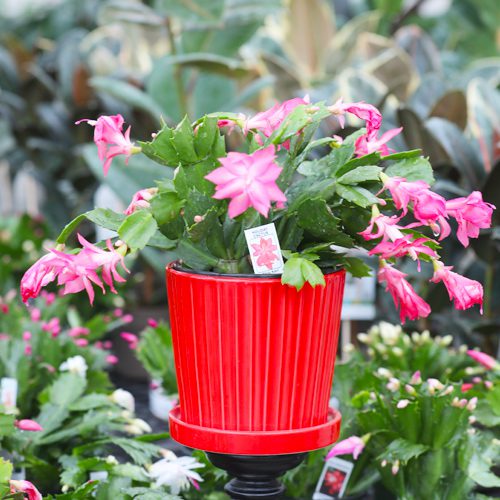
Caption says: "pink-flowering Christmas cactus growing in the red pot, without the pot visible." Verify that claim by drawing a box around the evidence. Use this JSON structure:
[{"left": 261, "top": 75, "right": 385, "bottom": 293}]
[{"left": 21, "top": 98, "right": 494, "bottom": 321}]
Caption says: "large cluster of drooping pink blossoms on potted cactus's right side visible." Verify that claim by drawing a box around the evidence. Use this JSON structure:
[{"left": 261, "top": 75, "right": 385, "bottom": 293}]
[{"left": 360, "top": 174, "right": 495, "bottom": 322}]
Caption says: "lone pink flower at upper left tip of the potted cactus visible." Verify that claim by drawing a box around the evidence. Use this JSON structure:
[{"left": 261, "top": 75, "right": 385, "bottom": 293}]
[{"left": 76, "top": 115, "right": 140, "bottom": 175}]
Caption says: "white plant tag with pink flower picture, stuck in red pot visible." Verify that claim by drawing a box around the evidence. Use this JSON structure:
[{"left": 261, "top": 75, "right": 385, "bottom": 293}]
[{"left": 245, "top": 223, "right": 284, "bottom": 274}]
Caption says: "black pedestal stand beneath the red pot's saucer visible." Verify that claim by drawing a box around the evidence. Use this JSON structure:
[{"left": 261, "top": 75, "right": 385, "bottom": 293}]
[{"left": 207, "top": 453, "right": 307, "bottom": 500}]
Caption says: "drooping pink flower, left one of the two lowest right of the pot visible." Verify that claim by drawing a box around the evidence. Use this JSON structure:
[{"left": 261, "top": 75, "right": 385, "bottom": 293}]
[{"left": 378, "top": 261, "right": 431, "bottom": 323}]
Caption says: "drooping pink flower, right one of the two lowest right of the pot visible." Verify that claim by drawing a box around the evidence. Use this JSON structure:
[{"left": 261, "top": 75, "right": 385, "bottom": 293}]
[{"left": 431, "top": 260, "right": 483, "bottom": 314}]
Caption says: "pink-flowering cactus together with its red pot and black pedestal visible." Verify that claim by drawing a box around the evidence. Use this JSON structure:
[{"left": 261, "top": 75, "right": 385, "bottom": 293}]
[{"left": 21, "top": 98, "right": 494, "bottom": 498}]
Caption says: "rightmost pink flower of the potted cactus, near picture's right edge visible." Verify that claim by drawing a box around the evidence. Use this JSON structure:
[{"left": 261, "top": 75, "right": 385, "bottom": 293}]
[{"left": 446, "top": 191, "right": 496, "bottom": 247}]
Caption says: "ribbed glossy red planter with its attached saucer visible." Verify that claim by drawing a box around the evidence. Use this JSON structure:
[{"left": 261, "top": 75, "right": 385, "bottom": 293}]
[{"left": 167, "top": 266, "right": 345, "bottom": 455}]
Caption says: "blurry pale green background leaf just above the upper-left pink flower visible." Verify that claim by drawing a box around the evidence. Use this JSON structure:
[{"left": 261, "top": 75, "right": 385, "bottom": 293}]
[{"left": 89, "top": 76, "right": 160, "bottom": 120}]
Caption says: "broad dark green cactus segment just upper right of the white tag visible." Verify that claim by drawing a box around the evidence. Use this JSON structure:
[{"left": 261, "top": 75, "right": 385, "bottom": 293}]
[{"left": 297, "top": 198, "right": 354, "bottom": 247}]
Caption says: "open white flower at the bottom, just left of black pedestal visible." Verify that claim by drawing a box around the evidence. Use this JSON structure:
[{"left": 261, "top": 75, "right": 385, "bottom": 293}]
[{"left": 149, "top": 453, "right": 204, "bottom": 495}]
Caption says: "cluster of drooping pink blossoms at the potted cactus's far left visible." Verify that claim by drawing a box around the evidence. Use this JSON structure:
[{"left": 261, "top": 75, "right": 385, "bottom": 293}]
[{"left": 21, "top": 234, "right": 128, "bottom": 304}]
